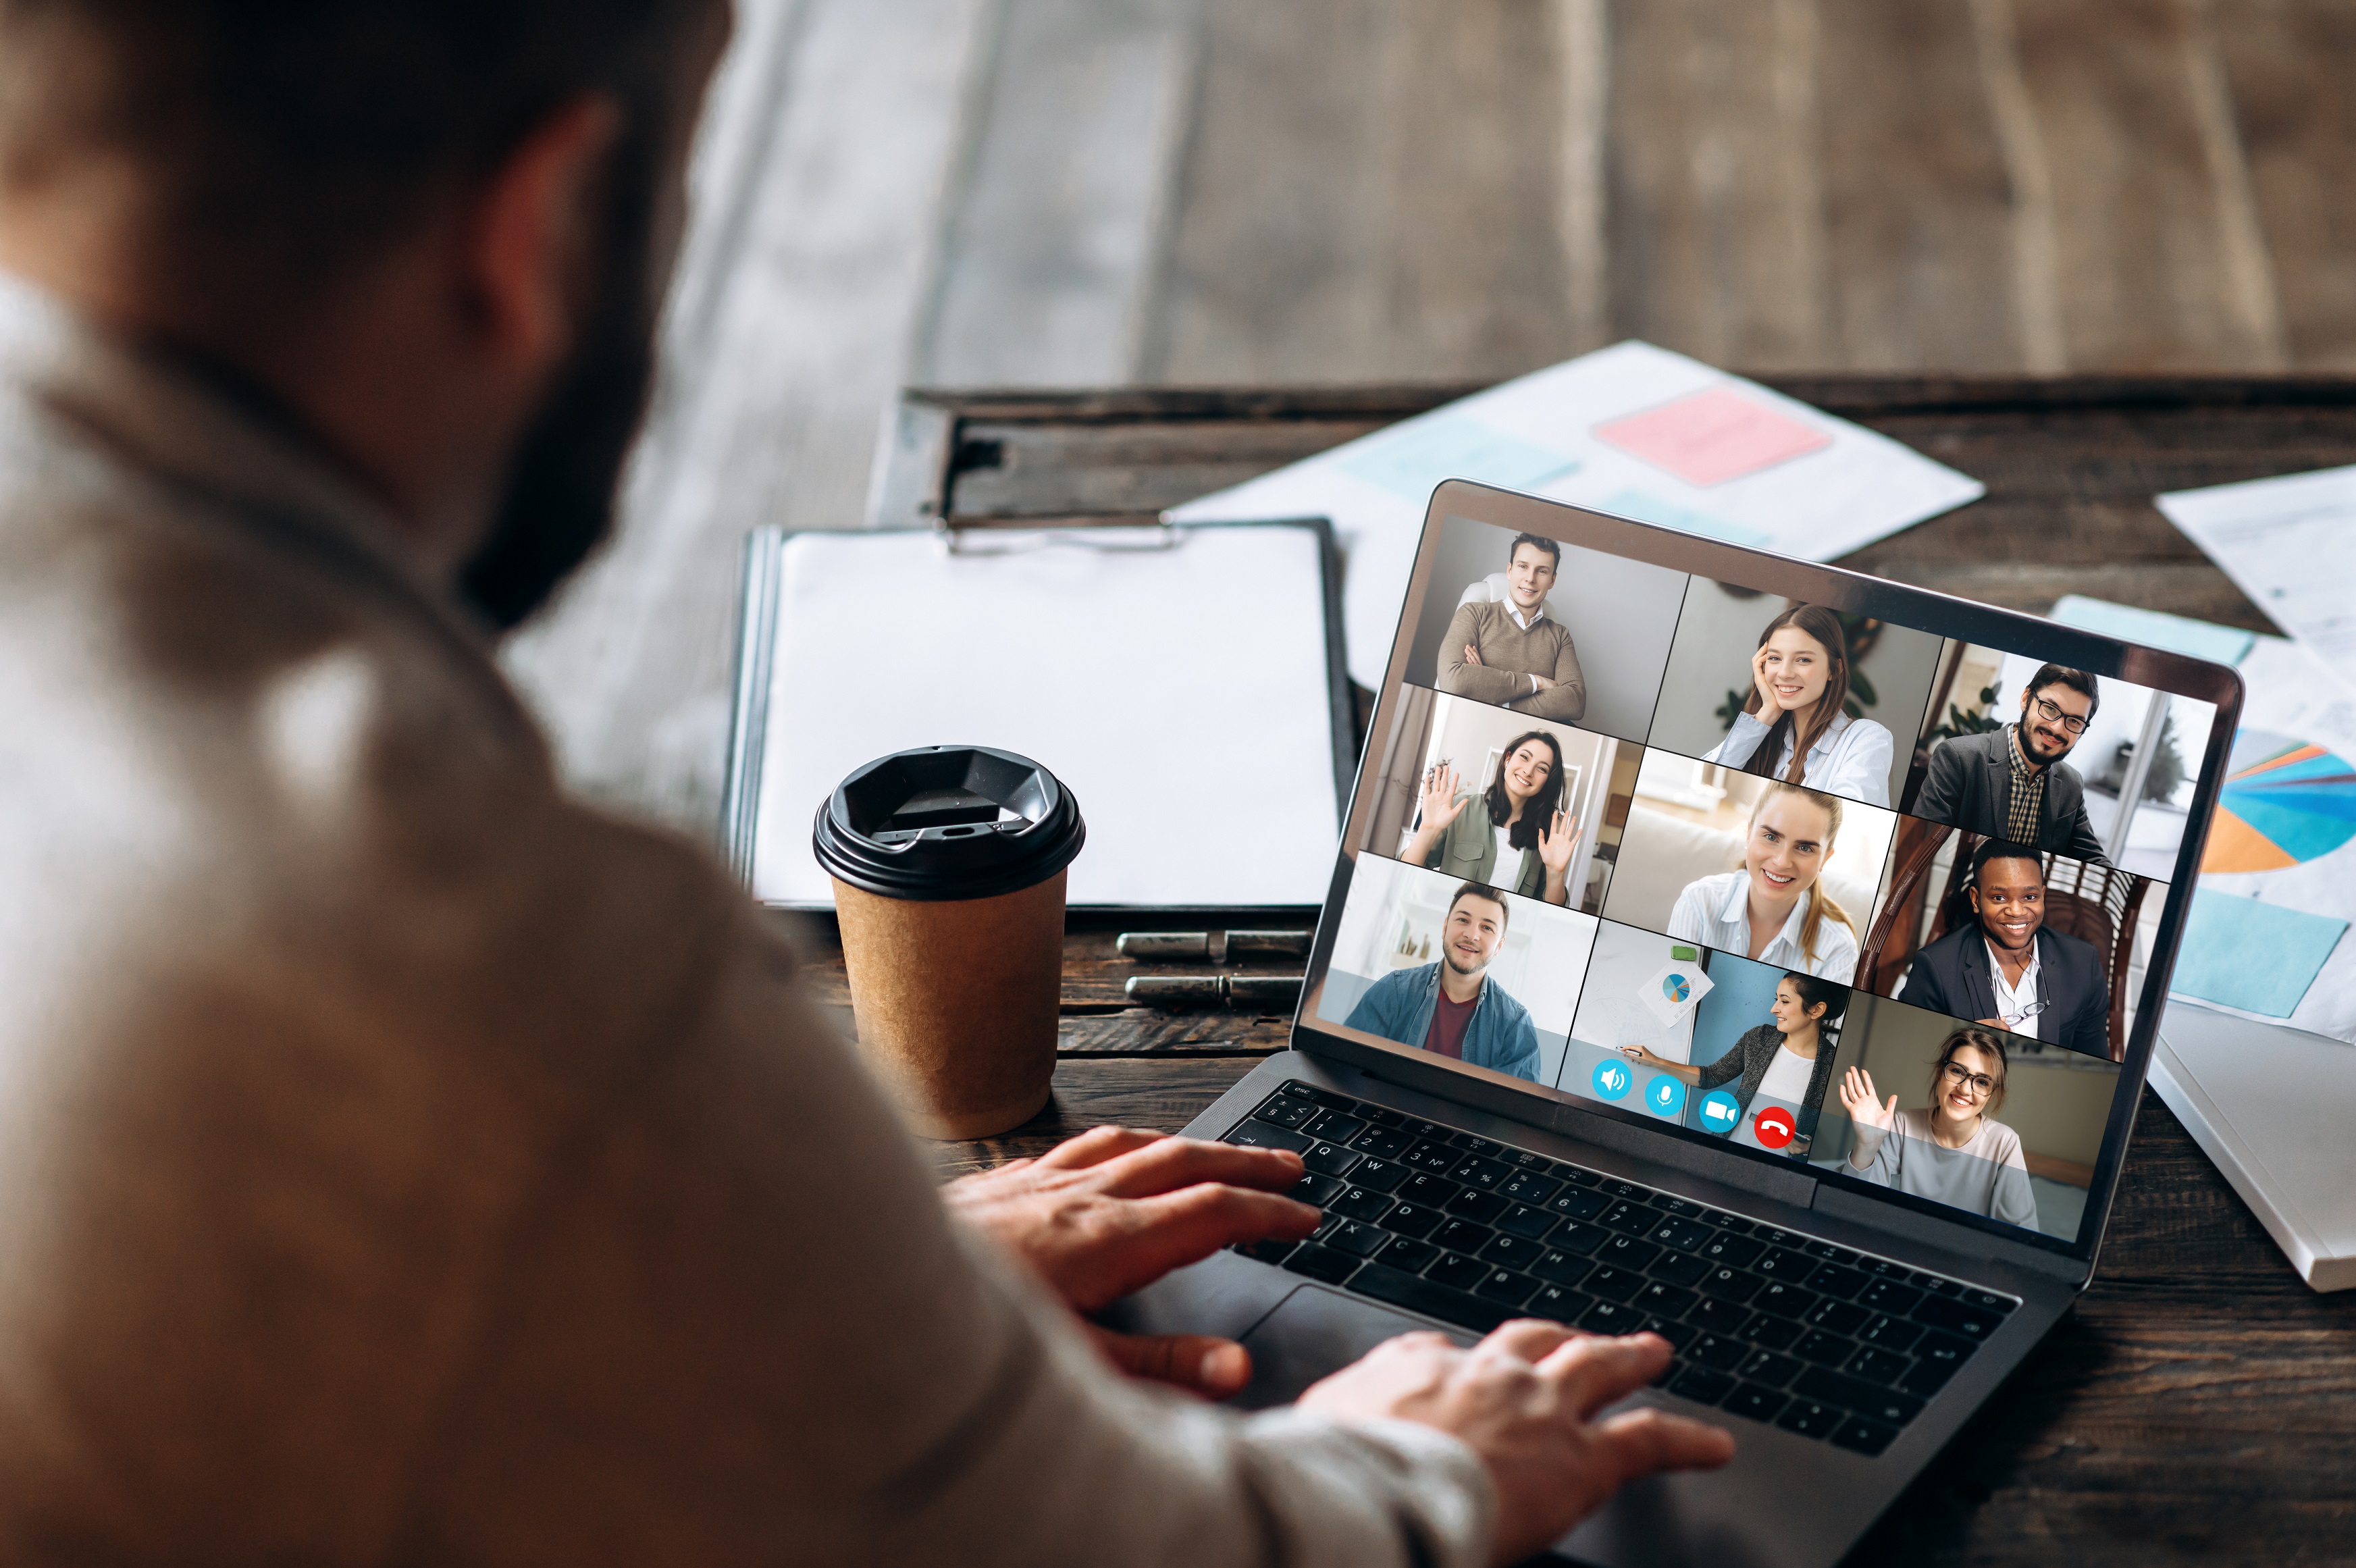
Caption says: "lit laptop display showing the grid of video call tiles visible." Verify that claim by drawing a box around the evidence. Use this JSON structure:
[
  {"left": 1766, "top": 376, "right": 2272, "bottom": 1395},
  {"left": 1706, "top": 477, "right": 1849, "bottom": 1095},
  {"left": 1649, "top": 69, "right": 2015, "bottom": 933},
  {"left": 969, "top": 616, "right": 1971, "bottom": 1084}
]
[{"left": 1303, "top": 485, "right": 2220, "bottom": 1248}]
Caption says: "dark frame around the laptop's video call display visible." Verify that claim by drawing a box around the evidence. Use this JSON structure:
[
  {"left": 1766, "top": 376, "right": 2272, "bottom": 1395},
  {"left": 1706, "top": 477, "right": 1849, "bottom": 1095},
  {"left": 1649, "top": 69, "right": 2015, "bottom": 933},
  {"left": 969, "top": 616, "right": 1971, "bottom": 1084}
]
[{"left": 1293, "top": 480, "right": 2243, "bottom": 1267}]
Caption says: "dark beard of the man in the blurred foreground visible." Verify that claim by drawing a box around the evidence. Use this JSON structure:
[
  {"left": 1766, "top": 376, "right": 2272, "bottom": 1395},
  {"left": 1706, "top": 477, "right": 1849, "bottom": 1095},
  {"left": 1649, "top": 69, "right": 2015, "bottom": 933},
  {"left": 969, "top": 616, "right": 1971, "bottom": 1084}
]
[{"left": 459, "top": 134, "right": 655, "bottom": 631}]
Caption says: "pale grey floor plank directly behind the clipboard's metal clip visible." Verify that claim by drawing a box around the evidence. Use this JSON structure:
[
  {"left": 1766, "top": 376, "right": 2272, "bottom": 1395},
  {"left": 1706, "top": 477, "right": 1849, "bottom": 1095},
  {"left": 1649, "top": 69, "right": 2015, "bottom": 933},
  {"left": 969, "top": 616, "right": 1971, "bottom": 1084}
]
[{"left": 916, "top": 0, "right": 1204, "bottom": 386}]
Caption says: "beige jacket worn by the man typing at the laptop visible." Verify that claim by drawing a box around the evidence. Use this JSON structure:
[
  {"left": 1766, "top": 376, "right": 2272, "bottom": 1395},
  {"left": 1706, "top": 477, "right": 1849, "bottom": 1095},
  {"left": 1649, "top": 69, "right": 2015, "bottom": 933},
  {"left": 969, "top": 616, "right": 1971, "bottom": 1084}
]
[{"left": 0, "top": 280, "right": 1489, "bottom": 1568}]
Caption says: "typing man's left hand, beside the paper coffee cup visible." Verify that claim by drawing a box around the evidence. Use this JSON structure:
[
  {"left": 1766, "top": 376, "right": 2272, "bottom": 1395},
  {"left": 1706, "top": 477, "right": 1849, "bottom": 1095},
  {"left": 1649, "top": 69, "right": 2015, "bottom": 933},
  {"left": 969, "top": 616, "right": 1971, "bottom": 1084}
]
[{"left": 940, "top": 1128, "right": 1317, "bottom": 1399}]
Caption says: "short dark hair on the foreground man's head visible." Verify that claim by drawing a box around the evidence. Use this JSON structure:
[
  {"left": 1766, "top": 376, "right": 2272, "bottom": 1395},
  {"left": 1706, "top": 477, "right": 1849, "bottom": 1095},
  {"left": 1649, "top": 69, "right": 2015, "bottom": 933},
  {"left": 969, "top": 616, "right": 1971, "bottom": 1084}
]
[{"left": 0, "top": 0, "right": 718, "bottom": 325}]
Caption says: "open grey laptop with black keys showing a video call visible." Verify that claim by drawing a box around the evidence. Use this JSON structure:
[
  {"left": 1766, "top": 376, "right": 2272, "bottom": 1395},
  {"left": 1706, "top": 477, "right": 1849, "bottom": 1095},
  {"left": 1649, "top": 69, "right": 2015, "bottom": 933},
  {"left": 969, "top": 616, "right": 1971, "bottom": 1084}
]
[{"left": 1117, "top": 480, "right": 2241, "bottom": 1568}]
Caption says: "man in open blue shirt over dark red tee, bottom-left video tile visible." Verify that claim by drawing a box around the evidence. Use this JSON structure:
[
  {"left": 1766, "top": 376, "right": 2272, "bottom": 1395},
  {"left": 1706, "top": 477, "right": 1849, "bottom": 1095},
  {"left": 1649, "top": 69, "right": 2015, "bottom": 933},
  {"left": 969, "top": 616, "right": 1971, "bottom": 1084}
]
[{"left": 1343, "top": 883, "right": 1538, "bottom": 1080}]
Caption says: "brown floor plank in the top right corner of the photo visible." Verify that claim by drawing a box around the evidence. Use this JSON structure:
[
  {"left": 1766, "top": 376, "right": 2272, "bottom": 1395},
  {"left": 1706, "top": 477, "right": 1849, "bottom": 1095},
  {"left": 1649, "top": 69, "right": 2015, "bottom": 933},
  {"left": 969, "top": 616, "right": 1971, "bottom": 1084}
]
[{"left": 2215, "top": 0, "right": 2356, "bottom": 367}]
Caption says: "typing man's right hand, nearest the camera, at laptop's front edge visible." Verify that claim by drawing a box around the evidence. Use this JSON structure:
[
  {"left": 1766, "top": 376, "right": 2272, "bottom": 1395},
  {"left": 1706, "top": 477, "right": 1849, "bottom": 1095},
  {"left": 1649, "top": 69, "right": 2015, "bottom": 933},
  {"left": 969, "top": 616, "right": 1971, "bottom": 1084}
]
[{"left": 1301, "top": 1318, "right": 1734, "bottom": 1563}]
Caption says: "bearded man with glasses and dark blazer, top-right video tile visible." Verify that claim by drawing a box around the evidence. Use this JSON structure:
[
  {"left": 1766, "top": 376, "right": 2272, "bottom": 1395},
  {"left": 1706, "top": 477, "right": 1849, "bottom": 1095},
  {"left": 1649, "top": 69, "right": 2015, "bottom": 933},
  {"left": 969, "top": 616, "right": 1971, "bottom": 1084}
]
[{"left": 1913, "top": 664, "right": 2111, "bottom": 866}]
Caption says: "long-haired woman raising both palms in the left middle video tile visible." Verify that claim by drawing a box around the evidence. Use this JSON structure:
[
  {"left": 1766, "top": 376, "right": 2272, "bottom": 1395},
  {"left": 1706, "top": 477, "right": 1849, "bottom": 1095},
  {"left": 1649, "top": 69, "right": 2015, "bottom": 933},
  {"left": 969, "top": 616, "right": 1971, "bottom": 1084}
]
[{"left": 1399, "top": 730, "right": 1579, "bottom": 904}]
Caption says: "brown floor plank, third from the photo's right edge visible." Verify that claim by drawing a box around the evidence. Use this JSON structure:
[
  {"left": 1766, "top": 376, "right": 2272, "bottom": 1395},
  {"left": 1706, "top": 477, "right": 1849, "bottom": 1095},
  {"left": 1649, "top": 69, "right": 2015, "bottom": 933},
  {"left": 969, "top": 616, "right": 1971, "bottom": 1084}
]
[{"left": 1819, "top": 0, "right": 2024, "bottom": 369}]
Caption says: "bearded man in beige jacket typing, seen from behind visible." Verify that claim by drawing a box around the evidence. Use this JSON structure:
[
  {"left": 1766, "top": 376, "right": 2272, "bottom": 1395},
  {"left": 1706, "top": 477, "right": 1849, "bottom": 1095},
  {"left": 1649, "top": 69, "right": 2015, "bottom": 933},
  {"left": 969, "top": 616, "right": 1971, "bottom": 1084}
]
[{"left": 0, "top": 0, "right": 1727, "bottom": 1566}]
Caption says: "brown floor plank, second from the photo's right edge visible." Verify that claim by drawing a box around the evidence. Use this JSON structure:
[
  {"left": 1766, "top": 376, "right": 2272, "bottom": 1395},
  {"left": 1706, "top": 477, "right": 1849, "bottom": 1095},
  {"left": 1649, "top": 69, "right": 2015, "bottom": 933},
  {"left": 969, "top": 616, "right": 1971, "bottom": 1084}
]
[{"left": 1984, "top": 0, "right": 2285, "bottom": 369}]
